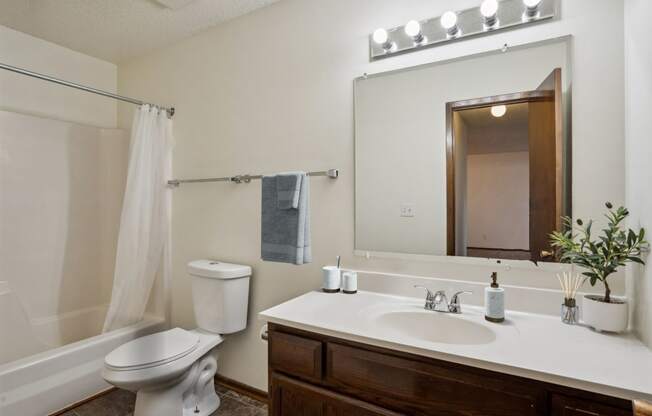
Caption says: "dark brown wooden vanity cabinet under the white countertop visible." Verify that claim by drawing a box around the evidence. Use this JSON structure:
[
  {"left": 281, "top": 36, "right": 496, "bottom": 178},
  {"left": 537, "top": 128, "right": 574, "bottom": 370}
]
[{"left": 269, "top": 324, "right": 632, "bottom": 416}]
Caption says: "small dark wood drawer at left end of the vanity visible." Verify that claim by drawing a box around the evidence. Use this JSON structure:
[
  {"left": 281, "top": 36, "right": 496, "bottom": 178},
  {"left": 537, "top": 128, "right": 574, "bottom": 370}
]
[{"left": 269, "top": 331, "right": 323, "bottom": 382}]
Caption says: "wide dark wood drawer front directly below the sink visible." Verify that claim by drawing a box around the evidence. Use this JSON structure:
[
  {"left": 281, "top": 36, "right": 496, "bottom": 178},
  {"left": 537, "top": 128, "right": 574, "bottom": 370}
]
[{"left": 324, "top": 342, "right": 546, "bottom": 416}]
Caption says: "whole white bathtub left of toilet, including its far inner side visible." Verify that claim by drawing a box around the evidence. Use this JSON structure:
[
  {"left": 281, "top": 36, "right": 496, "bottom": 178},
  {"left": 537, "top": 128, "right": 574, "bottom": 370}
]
[{"left": 0, "top": 285, "right": 166, "bottom": 416}]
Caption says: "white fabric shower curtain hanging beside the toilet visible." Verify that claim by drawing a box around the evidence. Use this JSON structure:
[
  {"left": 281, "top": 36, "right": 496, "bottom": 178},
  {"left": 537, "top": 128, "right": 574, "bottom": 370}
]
[{"left": 103, "top": 105, "right": 172, "bottom": 332}]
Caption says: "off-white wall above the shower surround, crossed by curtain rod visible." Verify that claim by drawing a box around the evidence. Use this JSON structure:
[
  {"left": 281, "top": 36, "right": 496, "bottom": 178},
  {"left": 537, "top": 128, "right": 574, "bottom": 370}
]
[{"left": 0, "top": 26, "right": 117, "bottom": 127}]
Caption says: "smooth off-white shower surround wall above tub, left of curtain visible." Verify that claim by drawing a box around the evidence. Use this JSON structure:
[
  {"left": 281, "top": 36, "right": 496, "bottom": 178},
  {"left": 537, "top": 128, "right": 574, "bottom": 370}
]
[{"left": 0, "top": 111, "right": 129, "bottom": 320}]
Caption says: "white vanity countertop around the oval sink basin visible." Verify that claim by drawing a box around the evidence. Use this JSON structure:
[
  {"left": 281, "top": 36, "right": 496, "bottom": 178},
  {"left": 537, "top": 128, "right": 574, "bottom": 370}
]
[{"left": 259, "top": 291, "right": 652, "bottom": 401}]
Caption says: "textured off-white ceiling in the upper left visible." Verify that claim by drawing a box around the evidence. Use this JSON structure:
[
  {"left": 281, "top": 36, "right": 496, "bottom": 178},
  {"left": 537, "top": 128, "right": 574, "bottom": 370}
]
[{"left": 0, "top": 0, "right": 278, "bottom": 63}]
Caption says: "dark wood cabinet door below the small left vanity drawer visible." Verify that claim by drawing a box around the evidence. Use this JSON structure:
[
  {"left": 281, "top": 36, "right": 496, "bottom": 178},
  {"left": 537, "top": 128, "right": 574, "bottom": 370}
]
[{"left": 270, "top": 373, "right": 401, "bottom": 416}]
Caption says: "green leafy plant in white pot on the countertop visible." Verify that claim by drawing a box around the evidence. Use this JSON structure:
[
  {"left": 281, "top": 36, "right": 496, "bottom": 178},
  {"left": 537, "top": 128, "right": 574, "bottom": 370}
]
[{"left": 550, "top": 202, "right": 649, "bottom": 332}]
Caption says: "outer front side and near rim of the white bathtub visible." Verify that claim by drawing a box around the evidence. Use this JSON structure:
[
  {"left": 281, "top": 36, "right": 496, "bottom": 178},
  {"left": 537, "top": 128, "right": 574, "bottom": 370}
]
[{"left": 0, "top": 316, "right": 165, "bottom": 416}]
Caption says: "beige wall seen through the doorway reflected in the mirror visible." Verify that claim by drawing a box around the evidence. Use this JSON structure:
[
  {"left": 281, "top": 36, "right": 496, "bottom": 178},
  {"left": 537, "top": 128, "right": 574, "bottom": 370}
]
[{"left": 466, "top": 152, "right": 530, "bottom": 250}]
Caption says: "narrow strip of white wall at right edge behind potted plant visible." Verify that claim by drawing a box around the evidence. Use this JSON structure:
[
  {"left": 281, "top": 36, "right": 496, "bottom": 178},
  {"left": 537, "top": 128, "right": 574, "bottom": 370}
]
[{"left": 625, "top": 0, "right": 652, "bottom": 348}]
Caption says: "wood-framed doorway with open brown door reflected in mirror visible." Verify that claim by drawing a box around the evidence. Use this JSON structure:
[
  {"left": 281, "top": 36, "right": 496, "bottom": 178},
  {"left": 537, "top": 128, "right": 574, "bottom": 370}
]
[{"left": 446, "top": 69, "right": 570, "bottom": 261}]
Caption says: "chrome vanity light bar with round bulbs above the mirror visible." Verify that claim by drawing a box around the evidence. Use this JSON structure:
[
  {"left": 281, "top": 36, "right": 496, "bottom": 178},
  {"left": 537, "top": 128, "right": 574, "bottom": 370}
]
[{"left": 368, "top": 0, "right": 556, "bottom": 61}]
